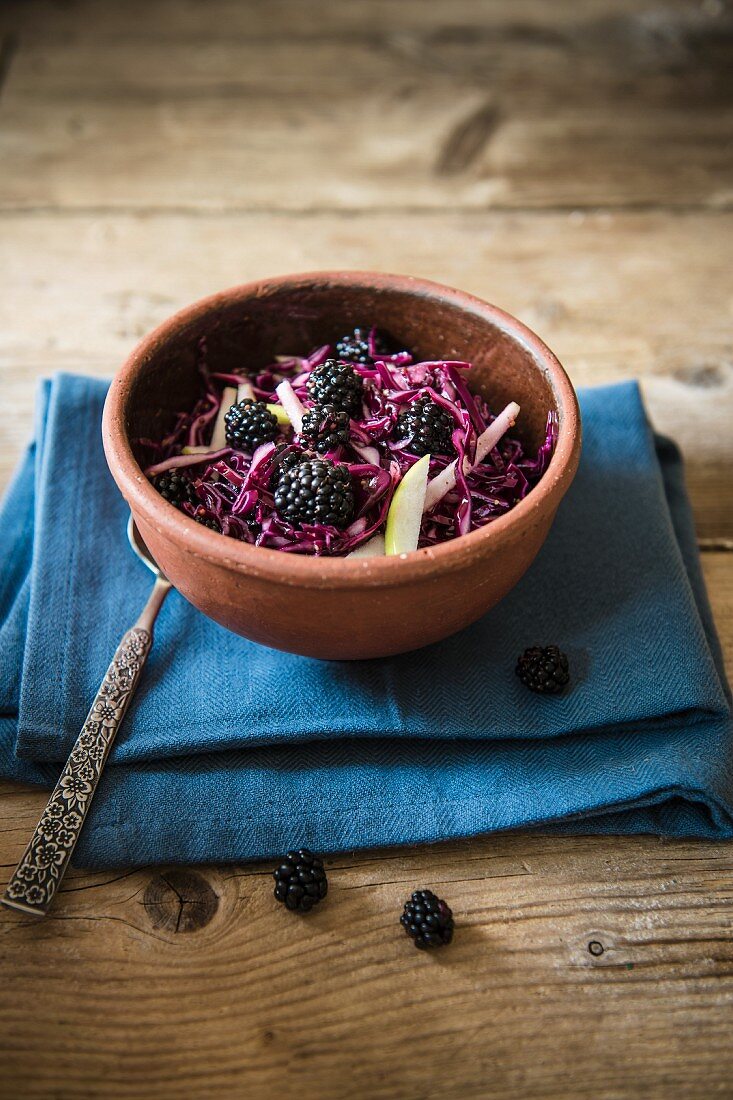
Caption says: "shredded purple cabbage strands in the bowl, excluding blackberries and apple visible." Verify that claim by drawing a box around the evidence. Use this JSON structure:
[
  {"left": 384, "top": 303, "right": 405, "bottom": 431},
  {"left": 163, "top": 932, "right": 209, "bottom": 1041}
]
[{"left": 138, "top": 329, "right": 557, "bottom": 556}]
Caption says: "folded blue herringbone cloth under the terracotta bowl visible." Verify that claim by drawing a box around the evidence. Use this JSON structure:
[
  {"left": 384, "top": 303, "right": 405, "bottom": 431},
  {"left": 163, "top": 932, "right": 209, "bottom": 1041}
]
[{"left": 0, "top": 375, "right": 733, "bottom": 867}]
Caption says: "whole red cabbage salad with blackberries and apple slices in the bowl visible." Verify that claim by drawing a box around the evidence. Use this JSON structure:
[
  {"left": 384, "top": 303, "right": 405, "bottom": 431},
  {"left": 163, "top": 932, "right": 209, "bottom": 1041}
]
[{"left": 138, "top": 328, "right": 557, "bottom": 556}]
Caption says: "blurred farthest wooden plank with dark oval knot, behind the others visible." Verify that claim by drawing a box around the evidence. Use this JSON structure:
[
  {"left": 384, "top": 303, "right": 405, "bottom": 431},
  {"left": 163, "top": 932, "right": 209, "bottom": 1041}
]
[{"left": 0, "top": 4, "right": 733, "bottom": 209}]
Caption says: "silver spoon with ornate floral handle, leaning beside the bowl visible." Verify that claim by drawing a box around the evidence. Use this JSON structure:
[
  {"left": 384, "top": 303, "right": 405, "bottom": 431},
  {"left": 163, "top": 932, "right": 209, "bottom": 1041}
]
[{"left": 0, "top": 516, "right": 171, "bottom": 916}]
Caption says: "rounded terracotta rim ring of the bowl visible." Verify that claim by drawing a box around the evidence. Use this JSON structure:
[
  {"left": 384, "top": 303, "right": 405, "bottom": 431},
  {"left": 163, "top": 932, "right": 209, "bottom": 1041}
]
[{"left": 102, "top": 271, "right": 580, "bottom": 589}]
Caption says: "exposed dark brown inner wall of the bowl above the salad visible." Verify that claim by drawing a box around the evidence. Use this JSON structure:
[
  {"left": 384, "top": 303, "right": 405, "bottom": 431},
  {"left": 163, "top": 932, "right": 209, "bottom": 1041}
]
[{"left": 125, "top": 278, "right": 560, "bottom": 461}]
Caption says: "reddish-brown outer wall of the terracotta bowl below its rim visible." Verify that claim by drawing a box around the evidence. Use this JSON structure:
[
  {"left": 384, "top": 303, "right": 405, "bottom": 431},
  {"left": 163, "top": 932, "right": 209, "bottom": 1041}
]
[{"left": 132, "top": 507, "right": 554, "bottom": 660}]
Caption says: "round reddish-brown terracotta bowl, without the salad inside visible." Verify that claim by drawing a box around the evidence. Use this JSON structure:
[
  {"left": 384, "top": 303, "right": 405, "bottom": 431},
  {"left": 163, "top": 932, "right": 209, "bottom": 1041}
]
[{"left": 103, "top": 272, "right": 580, "bottom": 659}]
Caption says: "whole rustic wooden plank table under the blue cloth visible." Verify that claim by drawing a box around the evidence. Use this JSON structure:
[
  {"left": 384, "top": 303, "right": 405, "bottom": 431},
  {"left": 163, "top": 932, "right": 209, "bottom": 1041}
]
[{"left": 0, "top": 0, "right": 733, "bottom": 1100}]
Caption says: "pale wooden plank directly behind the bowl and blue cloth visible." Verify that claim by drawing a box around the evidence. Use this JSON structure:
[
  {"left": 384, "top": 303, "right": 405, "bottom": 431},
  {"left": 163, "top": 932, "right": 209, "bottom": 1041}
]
[{"left": 0, "top": 212, "right": 733, "bottom": 539}]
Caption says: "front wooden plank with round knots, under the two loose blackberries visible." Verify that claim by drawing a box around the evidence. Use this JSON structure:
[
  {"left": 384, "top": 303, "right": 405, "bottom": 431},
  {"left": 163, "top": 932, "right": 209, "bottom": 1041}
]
[{"left": 0, "top": 553, "right": 733, "bottom": 1100}]
